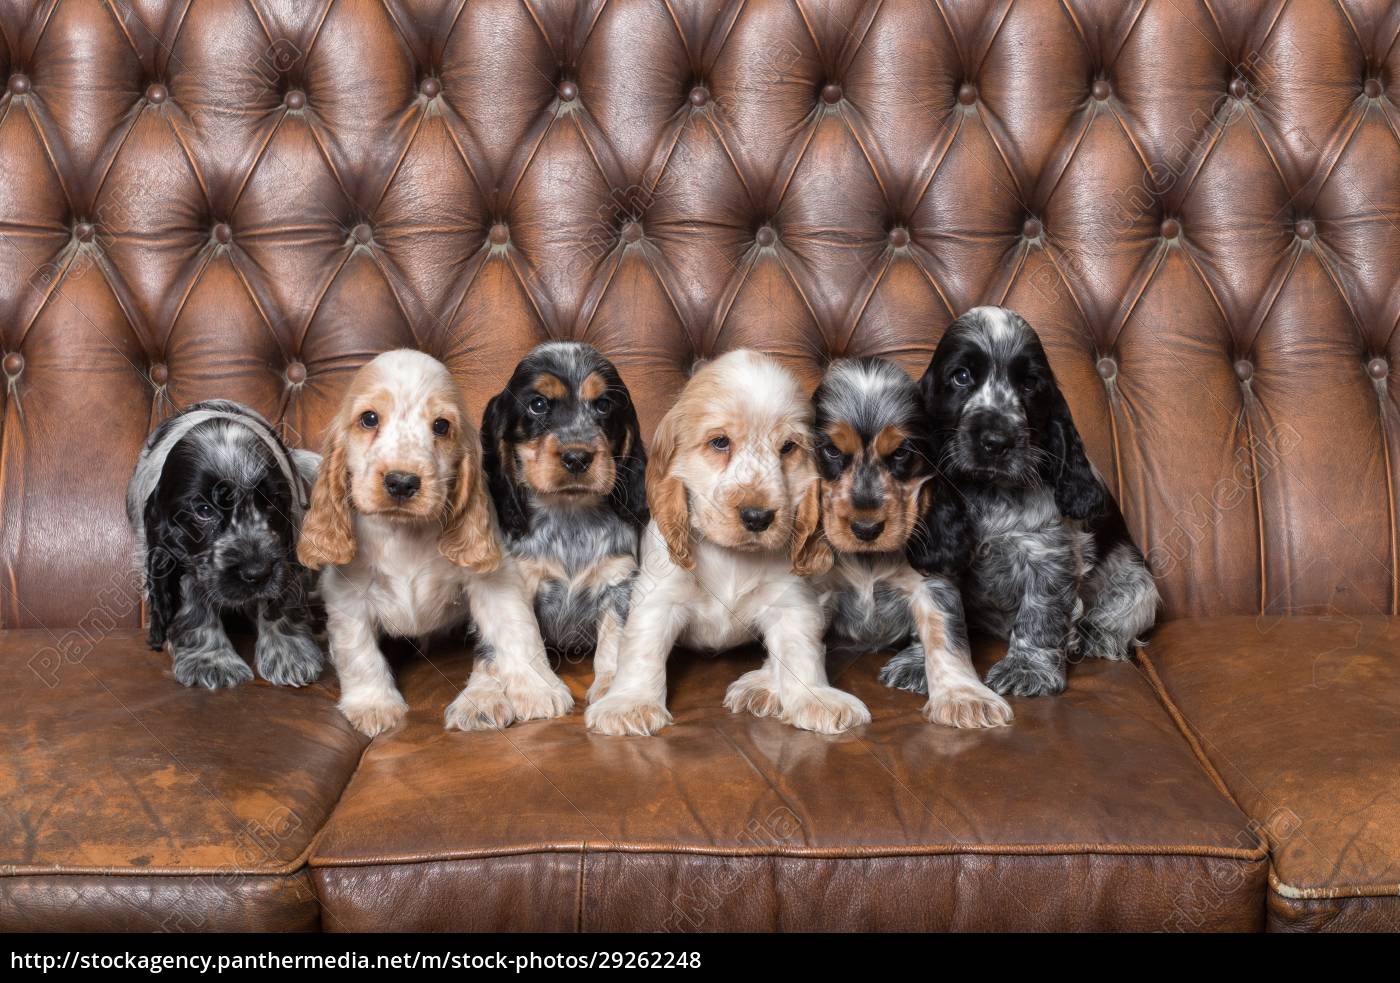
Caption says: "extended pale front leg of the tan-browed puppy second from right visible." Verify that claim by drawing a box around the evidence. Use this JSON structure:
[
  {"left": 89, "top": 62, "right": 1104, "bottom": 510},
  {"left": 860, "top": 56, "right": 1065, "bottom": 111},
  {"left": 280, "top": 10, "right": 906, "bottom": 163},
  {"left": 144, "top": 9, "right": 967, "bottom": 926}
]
[{"left": 904, "top": 571, "right": 1012, "bottom": 727}]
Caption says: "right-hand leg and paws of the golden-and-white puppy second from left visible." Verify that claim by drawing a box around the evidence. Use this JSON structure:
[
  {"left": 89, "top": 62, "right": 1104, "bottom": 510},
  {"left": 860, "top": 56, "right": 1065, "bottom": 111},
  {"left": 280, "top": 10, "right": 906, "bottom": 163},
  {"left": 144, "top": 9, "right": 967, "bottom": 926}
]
[{"left": 447, "top": 562, "right": 574, "bottom": 730}]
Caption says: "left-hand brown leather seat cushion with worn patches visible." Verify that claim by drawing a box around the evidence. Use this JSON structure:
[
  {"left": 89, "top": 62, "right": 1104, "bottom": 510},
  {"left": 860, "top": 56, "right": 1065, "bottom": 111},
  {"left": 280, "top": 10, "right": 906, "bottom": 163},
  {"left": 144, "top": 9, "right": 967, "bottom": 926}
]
[{"left": 0, "top": 630, "right": 364, "bottom": 931}]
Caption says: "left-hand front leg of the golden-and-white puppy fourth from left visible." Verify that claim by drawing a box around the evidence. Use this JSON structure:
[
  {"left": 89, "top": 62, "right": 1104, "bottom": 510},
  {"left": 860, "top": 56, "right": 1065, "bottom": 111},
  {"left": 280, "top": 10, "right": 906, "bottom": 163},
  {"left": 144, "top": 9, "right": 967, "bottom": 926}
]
[{"left": 584, "top": 590, "right": 685, "bottom": 737}]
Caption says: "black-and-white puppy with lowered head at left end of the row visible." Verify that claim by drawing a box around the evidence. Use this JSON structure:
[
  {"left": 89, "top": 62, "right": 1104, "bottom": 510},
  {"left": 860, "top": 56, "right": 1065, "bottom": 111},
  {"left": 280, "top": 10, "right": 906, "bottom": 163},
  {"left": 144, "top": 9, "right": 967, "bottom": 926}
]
[{"left": 126, "top": 399, "right": 323, "bottom": 689}]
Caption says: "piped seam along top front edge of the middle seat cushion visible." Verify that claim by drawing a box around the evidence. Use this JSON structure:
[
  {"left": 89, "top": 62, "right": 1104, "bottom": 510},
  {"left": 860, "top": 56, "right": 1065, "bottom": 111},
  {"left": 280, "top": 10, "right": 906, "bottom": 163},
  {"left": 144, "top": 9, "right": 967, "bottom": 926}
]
[{"left": 311, "top": 842, "right": 1268, "bottom": 870}]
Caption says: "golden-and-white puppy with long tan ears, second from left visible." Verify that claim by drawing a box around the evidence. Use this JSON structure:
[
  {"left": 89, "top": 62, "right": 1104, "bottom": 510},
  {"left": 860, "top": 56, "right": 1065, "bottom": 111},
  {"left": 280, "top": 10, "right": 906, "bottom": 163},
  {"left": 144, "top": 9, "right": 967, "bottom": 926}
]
[{"left": 297, "top": 350, "right": 573, "bottom": 737}]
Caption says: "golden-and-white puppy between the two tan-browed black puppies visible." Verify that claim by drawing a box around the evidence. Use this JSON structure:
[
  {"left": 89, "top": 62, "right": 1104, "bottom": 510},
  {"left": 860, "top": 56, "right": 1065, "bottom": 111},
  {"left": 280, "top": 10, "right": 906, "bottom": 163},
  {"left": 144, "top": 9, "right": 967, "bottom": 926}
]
[{"left": 585, "top": 350, "right": 869, "bottom": 735}]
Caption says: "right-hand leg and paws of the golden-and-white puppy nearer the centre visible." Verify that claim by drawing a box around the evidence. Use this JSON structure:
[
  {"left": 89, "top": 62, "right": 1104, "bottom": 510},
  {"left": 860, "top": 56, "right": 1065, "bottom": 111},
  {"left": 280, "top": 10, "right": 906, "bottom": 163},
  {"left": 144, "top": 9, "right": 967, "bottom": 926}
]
[{"left": 724, "top": 583, "right": 871, "bottom": 734}]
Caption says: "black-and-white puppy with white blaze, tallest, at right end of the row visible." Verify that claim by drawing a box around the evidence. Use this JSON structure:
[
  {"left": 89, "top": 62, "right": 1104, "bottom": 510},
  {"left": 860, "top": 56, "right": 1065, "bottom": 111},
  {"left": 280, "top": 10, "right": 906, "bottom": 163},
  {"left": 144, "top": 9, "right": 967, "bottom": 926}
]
[{"left": 882, "top": 307, "right": 1158, "bottom": 696}]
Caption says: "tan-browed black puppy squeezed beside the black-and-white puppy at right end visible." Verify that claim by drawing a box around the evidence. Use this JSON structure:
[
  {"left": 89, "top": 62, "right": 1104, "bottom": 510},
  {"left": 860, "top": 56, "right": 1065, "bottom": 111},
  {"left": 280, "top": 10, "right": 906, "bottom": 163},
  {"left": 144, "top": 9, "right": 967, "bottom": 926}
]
[{"left": 812, "top": 358, "right": 1011, "bottom": 727}]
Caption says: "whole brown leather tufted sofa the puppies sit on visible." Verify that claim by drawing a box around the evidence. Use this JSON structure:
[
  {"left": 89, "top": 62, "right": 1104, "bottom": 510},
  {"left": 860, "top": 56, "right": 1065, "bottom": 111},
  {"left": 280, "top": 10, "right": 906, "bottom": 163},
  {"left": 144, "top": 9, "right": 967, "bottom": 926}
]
[{"left": 0, "top": 0, "right": 1400, "bottom": 931}]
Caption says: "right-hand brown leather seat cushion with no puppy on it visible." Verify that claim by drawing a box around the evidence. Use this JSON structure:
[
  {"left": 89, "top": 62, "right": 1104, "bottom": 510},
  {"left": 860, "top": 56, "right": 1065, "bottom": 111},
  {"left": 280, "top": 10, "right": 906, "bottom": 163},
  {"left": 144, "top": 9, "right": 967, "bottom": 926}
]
[{"left": 1147, "top": 613, "right": 1400, "bottom": 931}]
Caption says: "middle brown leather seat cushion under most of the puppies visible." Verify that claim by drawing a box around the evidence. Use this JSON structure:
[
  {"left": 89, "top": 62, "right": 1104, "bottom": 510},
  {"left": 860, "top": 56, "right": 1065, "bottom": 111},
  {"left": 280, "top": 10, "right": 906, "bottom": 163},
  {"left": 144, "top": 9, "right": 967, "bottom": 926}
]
[{"left": 311, "top": 638, "right": 1266, "bottom": 931}]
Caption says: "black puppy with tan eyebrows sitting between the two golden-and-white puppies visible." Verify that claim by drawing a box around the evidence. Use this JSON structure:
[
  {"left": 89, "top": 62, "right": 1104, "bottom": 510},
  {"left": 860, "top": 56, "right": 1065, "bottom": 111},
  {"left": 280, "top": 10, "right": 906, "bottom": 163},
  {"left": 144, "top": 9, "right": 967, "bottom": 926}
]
[{"left": 482, "top": 342, "right": 650, "bottom": 700}]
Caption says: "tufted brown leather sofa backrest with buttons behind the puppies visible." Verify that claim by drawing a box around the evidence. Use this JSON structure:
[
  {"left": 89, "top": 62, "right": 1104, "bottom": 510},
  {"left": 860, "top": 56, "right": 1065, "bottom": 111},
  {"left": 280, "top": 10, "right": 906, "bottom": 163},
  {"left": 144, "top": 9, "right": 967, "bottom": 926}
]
[{"left": 0, "top": 0, "right": 1400, "bottom": 629}]
